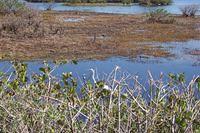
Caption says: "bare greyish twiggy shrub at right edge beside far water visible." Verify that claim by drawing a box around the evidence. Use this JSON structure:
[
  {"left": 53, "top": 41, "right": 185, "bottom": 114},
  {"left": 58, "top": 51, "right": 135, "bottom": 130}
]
[{"left": 180, "top": 5, "right": 199, "bottom": 17}]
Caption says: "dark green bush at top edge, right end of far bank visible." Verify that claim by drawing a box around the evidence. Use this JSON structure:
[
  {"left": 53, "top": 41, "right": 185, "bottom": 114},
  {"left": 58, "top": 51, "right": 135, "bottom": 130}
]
[{"left": 139, "top": 0, "right": 172, "bottom": 6}]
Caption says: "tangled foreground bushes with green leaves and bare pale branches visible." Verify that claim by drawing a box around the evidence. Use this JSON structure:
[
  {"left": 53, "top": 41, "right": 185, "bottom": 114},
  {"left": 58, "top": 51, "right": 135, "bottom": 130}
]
[{"left": 0, "top": 63, "right": 200, "bottom": 133}]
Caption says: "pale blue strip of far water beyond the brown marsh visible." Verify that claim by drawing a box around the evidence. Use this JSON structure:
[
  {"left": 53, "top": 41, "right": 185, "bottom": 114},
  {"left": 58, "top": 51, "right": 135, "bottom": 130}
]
[{"left": 23, "top": 0, "right": 200, "bottom": 14}]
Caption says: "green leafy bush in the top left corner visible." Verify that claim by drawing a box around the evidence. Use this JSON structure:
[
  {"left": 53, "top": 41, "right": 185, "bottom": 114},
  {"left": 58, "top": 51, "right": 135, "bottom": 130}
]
[{"left": 0, "top": 0, "right": 26, "bottom": 14}]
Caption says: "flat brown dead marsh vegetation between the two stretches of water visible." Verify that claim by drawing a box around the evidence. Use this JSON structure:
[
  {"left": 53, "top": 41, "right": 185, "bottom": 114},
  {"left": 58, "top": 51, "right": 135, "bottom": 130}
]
[{"left": 0, "top": 11, "right": 200, "bottom": 60}]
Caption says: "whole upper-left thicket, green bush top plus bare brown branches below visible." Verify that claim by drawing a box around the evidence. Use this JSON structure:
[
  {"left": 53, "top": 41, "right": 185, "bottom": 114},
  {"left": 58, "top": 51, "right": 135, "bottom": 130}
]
[{"left": 0, "top": 0, "right": 64, "bottom": 38}]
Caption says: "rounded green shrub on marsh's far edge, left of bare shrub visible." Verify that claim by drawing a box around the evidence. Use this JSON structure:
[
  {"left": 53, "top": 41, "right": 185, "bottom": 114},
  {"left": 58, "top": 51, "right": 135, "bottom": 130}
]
[{"left": 146, "top": 9, "right": 174, "bottom": 23}]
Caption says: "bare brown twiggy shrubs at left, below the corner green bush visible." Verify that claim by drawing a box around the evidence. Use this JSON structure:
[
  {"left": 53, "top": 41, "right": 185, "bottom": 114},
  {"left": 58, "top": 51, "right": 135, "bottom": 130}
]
[{"left": 0, "top": 9, "right": 64, "bottom": 38}]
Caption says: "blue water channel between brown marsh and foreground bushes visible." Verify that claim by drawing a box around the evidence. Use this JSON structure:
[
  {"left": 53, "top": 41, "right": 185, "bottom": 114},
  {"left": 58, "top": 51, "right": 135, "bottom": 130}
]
[{"left": 0, "top": 40, "right": 200, "bottom": 82}]
